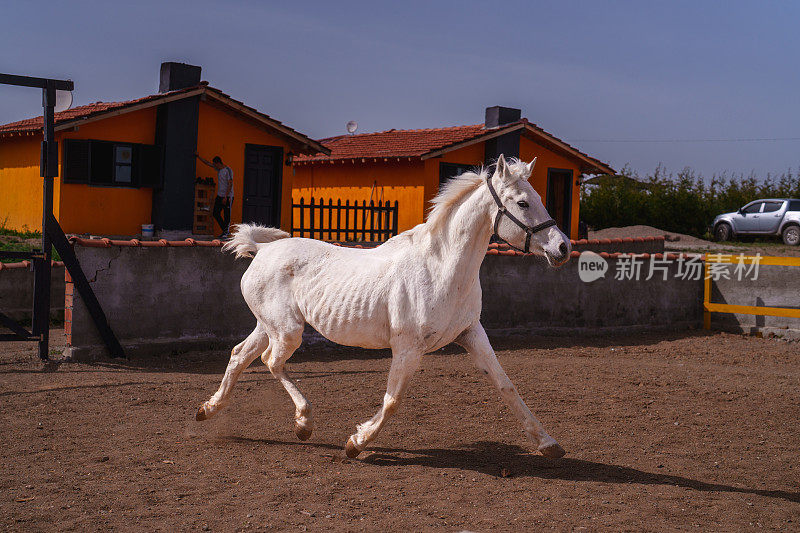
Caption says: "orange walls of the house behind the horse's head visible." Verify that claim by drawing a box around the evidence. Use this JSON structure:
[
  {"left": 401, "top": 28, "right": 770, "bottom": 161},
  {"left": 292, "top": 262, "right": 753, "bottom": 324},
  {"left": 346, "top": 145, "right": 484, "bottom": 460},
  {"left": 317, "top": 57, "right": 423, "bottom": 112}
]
[{"left": 292, "top": 138, "right": 580, "bottom": 241}]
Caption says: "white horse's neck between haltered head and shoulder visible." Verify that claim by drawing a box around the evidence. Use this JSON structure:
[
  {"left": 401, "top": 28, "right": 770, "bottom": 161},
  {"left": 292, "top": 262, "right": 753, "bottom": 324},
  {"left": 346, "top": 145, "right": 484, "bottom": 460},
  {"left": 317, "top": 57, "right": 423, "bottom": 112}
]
[{"left": 429, "top": 186, "right": 493, "bottom": 280}]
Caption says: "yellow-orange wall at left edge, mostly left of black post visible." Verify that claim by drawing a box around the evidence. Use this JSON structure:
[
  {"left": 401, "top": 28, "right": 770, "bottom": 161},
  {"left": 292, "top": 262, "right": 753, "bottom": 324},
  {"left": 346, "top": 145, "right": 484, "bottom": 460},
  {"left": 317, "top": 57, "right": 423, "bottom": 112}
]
[{"left": 0, "top": 135, "right": 59, "bottom": 231}]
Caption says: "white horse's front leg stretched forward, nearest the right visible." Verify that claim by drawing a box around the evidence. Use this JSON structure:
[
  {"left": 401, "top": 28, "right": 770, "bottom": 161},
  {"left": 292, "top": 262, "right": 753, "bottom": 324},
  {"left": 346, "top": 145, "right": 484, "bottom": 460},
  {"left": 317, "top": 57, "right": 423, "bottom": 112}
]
[{"left": 455, "top": 322, "right": 565, "bottom": 457}]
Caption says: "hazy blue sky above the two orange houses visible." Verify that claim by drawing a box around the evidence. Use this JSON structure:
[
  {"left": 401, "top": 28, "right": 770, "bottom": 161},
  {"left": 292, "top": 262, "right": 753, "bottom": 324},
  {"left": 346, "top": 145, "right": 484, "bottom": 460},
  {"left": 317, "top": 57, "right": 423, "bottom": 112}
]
[{"left": 0, "top": 0, "right": 800, "bottom": 176}]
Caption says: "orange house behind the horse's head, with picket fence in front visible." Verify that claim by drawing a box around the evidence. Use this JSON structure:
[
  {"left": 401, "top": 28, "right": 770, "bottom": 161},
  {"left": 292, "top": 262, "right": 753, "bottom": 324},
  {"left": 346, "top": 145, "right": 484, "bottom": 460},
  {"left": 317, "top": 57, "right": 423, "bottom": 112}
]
[{"left": 292, "top": 106, "right": 614, "bottom": 238}]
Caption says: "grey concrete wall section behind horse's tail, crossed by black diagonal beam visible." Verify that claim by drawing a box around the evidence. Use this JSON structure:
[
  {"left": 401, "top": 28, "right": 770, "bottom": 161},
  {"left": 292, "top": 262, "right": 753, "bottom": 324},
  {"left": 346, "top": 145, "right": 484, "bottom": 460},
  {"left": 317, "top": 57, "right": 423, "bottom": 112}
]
[{"left": 65, "top": 246, "right": 256, "bottom": 360}]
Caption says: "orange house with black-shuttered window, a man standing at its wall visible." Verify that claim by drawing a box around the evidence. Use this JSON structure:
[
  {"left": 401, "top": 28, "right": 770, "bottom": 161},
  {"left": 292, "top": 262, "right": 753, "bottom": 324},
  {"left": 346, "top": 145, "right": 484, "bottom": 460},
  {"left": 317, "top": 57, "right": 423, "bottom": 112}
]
[{"left": 0, "top": 63, "right": 328, "bottom": 235}]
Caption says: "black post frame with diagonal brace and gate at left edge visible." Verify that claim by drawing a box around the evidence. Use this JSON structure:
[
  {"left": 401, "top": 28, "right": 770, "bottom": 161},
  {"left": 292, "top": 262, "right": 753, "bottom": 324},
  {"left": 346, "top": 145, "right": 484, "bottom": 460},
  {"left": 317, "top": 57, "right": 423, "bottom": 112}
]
[{"left": 0, "top": 74, "right": 125, "bottom": 361}]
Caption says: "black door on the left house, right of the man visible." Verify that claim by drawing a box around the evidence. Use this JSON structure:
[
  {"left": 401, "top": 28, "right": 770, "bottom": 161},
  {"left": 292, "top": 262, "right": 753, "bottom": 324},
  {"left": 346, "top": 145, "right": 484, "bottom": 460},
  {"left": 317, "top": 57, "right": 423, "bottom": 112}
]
[{"left": 242, "top": 144, "right": 283, "bottom": 228}]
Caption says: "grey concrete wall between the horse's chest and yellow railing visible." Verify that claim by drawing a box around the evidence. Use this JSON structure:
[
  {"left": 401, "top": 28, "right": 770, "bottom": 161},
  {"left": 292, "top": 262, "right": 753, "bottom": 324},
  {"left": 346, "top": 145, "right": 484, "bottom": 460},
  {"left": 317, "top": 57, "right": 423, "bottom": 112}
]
[{"left": 481, "top": 256, "right": 703, "bottom": 334}]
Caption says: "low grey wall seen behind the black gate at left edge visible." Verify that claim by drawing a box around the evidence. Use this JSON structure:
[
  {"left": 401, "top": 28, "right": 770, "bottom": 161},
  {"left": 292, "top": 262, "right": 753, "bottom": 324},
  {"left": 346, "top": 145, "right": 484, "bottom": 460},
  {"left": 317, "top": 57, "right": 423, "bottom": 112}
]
[{"left": 0, "top": 265, "right": 64, "bottom": 322}]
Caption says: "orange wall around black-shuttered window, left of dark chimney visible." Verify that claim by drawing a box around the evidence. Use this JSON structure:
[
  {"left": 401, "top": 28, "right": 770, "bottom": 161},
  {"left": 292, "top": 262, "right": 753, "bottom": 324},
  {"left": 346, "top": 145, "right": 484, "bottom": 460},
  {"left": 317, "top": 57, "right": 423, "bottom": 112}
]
[{"left": 56, "top": 107, "right": 156, "bottom": 235}]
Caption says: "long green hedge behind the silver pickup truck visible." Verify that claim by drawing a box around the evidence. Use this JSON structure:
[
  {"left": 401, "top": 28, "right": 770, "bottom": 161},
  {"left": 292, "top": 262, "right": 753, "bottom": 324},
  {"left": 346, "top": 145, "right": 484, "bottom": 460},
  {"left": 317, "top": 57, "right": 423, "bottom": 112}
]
[{"left": 581, "top": 165, "right": 800, "bottom": 237}]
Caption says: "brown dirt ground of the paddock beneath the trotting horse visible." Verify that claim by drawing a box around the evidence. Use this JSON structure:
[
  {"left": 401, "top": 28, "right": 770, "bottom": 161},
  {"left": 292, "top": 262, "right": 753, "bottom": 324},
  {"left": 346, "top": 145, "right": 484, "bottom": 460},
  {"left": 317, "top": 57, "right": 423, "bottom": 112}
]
[{"left": 0, "top": 332, "right": 800, "bottom": 532}]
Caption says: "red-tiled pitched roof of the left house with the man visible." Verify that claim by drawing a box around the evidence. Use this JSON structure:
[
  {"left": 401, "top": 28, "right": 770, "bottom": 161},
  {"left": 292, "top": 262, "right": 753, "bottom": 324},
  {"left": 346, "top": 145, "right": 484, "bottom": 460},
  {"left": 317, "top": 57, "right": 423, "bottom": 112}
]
[{"left": 0, "top": 82, "right": 329, "bottom": 154}]
